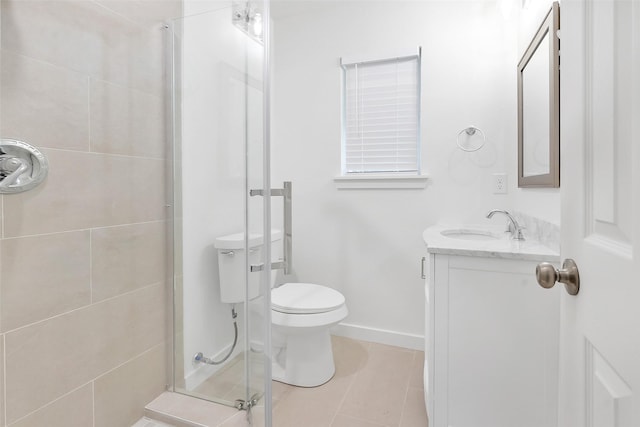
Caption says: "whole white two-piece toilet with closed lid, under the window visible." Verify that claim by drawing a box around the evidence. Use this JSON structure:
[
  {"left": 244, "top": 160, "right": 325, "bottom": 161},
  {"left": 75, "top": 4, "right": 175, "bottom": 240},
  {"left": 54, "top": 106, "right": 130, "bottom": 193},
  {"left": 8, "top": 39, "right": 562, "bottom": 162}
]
[{"left": 215, "top": 231, "right": 348, "bottom": 387}]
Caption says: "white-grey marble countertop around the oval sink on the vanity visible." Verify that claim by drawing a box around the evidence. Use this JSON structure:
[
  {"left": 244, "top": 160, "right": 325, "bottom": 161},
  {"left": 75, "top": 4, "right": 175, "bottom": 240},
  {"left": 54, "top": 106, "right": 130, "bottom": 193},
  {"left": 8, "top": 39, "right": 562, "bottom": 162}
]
[{"left": 422, "top": 224, "right": 560, "bottom": 262}]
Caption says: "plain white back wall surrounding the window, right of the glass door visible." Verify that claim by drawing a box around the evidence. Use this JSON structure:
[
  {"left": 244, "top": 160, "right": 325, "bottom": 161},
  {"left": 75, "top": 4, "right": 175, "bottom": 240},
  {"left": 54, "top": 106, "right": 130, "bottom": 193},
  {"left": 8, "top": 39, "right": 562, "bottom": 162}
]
[{"left": 272, "top": 1, "right": 527, "bottom": 345}]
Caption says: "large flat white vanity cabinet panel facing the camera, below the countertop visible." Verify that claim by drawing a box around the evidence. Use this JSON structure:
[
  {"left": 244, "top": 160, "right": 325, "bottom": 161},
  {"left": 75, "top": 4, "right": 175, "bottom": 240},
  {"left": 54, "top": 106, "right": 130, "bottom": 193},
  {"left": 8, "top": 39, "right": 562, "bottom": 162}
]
[{"left": 432, "top": 256, "right": 560, "bottom": 427}]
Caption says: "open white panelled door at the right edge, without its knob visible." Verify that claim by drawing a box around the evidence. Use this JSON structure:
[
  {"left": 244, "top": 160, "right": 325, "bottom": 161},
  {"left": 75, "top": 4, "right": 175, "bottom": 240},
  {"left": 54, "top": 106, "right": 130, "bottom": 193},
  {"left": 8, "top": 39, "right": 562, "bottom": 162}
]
[{"left": 558, "top": 0, "right": 640, "bottom": 427}]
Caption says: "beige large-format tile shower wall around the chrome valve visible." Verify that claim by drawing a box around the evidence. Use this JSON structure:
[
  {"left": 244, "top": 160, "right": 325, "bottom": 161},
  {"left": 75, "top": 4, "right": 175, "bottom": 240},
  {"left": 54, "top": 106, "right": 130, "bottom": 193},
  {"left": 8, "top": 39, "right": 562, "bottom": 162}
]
[{"left": 0, "top": 0, "right": 182, "bottom": 427}]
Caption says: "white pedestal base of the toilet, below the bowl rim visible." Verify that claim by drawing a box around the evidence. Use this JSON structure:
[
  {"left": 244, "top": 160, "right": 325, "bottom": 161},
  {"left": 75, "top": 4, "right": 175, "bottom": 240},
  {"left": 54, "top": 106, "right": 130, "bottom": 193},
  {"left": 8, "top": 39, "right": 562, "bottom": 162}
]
[{"left": 272, "top": 327, "right": 336, "bottom": 387}]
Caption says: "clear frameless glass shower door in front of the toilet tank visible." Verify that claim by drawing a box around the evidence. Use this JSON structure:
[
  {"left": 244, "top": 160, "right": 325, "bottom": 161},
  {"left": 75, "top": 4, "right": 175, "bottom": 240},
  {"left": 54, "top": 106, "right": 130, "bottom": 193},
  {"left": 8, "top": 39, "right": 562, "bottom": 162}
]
[{"left": 168, "top": 0, "right": 271, "bottom": 425}]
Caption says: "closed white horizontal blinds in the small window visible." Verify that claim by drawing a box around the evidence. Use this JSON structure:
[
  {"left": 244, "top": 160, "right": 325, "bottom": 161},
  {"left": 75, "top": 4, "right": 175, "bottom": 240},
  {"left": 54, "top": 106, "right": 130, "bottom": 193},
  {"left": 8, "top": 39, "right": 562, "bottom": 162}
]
[{"left": 342, "top": 55, "right": 420, "bottom": 175}]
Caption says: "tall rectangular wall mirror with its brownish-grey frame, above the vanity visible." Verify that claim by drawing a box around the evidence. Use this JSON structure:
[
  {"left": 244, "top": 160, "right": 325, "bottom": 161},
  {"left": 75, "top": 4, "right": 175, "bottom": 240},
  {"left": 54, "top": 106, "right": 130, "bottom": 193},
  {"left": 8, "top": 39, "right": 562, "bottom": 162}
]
[{"left": 518, "top": 2, "right": 560, "bottom": 188}]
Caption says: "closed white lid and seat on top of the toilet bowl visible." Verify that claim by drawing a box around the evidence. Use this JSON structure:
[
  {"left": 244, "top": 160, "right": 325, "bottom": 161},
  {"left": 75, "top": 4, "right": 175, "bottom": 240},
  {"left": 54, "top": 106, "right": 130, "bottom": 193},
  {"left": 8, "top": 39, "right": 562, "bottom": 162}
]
[{"left": 271, "top": 283, "right": 344, "bottom": 314}]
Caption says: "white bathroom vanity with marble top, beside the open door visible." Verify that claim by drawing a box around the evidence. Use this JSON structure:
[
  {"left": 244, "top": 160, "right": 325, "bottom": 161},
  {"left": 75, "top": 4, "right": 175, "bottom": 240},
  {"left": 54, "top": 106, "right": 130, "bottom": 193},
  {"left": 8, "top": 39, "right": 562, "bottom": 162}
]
[{"left": 423, "top": 226, "right": 560, "bottom": 427}]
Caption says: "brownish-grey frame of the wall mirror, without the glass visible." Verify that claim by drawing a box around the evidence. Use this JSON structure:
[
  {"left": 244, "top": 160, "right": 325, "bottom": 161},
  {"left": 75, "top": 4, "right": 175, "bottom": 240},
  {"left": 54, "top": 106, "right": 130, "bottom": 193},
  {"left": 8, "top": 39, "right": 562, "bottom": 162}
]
[{"left": 518, "top": 2, "right": 560, "bottom": 188}]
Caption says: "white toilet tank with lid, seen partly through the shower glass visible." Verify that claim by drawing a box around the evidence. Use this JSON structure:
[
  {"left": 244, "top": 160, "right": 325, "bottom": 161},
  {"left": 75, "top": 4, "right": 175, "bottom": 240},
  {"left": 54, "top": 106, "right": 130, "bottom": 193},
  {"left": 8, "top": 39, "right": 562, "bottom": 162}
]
[{"left": 214, "top": 230, "right": 282, "bottom": 304}]
